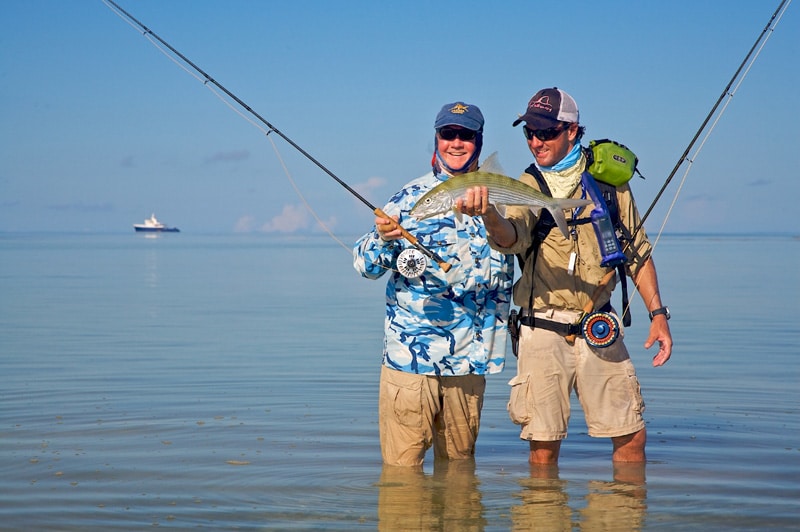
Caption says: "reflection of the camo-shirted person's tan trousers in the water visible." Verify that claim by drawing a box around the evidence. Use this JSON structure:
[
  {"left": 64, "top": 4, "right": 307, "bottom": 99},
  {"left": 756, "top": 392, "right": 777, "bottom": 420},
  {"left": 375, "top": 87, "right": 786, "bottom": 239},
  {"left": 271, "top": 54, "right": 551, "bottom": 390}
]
[{"left": 378, "top": 459, "right": 486, "bottom": 531}]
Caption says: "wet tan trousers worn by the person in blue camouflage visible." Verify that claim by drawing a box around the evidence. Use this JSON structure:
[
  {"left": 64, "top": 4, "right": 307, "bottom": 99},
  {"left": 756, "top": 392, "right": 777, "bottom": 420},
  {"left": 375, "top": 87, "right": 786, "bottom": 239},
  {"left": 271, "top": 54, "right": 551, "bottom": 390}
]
[{"left": 378, "top": 366, "right": 486, "bottom": 466}]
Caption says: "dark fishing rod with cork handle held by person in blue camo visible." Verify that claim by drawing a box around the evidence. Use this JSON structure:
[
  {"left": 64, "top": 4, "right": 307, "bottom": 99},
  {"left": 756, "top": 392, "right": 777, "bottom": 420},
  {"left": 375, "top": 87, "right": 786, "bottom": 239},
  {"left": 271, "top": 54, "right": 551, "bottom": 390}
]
[{"left": 102, "top": 0, "right": 451, "bottom": 272}]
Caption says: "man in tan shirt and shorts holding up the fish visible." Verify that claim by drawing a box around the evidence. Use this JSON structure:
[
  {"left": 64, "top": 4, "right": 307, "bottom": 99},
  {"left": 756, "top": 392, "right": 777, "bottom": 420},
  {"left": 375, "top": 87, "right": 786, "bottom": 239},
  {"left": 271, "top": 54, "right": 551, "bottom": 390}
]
[{"left": 457, "top": 88, "right": 672, "bottom": 465}]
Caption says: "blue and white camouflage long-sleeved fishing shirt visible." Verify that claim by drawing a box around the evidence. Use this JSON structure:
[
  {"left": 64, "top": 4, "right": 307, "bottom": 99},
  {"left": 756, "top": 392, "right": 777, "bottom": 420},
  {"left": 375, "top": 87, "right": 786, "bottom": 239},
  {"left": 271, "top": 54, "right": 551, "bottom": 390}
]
[{"left": 353, "top": 173, "right": 514, "bottom": 376}]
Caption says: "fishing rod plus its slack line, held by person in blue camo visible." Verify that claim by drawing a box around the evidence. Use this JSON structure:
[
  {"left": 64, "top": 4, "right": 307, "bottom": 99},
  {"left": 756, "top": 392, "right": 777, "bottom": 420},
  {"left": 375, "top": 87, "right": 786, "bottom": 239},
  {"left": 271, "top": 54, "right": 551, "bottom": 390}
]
[{"left": 101, "top": 0, "right": 451, "bottom": 272}]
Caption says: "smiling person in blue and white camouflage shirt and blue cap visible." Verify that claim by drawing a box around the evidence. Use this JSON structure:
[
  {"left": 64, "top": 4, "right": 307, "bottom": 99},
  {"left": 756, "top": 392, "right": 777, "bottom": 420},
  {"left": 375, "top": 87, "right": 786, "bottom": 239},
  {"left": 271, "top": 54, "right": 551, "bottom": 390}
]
[{"left": 353, "top": 102, "right": 514, "bottom": 466}]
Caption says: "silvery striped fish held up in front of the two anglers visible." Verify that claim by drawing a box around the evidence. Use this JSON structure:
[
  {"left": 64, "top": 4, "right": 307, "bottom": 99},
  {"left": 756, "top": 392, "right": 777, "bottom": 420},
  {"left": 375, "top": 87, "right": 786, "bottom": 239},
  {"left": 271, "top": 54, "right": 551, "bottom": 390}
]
[{"left": 411, "top": 170, "right": 592, "bottom": 238}]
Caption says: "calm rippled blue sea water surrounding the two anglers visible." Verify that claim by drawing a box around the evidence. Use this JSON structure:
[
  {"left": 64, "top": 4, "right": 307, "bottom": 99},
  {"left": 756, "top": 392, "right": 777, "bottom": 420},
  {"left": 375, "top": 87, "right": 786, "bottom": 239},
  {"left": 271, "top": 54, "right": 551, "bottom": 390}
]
[{"left": 0, "top": 233, "right": 800, "bottom": 531}]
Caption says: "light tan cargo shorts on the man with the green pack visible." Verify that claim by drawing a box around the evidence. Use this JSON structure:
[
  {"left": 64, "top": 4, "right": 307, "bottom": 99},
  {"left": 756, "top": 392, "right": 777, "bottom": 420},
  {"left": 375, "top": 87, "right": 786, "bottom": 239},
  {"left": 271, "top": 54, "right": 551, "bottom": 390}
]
[{"left": 508, "top": 308, "right": 645, "bottom": 441}]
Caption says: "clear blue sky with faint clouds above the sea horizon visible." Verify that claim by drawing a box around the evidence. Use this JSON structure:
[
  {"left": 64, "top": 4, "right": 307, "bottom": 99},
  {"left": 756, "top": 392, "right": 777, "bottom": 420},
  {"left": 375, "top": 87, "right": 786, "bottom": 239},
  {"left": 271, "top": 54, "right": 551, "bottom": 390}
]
[{"left": 0, "top": 0, "right": 800, "bottom": 235}]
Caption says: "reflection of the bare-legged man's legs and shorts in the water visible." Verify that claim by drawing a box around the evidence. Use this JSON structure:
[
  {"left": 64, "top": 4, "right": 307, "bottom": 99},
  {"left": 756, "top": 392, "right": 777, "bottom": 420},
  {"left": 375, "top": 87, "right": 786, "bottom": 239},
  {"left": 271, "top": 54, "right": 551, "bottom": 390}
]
[{"left": 511, "top": 464, "right": 647, "bottom": 530}]
